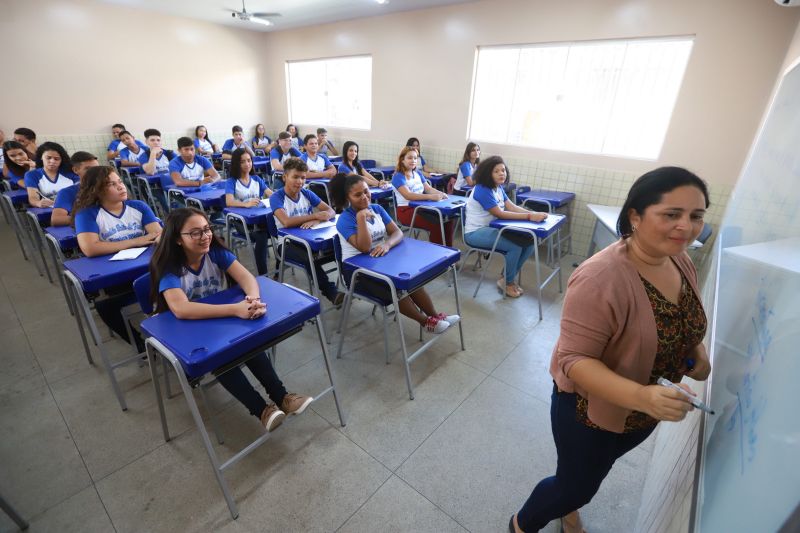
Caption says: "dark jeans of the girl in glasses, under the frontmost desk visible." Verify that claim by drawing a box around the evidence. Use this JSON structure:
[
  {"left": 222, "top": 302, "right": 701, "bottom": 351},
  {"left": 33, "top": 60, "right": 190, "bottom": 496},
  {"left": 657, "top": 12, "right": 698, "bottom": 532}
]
[{"left": 217, "top": 353, "right": 286, "bottom": 417}]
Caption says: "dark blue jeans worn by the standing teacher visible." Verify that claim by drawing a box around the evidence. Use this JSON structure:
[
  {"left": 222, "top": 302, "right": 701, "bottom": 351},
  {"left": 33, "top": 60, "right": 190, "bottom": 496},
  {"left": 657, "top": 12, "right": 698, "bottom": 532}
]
[{"left": 517, "top": 385, "right": 655, "bottom": 533}]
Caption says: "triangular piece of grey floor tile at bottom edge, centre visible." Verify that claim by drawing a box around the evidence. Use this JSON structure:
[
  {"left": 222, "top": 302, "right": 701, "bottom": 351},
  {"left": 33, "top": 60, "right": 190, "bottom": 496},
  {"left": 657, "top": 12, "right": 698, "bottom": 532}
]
[{"left": 338, "top": 476, "right": 466, "bottom": 533}]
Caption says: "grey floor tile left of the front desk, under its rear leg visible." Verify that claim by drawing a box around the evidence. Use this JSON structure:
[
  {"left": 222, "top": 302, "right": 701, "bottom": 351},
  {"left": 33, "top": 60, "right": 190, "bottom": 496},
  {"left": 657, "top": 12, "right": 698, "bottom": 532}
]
[{"left": 52, "top": 364, "right": 199, "bottom": 481}]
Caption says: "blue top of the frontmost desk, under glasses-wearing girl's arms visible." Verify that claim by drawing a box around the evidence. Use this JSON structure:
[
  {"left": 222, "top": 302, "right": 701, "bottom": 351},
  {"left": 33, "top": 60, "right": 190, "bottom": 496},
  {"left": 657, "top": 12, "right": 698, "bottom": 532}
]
[{"left": 142, "top": 276, "right": 320, "bottom": 378}]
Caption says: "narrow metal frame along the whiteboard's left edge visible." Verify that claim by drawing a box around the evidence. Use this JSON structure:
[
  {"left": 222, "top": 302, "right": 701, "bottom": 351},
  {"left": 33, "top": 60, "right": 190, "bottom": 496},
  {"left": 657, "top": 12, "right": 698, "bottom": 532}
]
[{"left": 689, "top": 57, "right": 800, "bottom": 533}]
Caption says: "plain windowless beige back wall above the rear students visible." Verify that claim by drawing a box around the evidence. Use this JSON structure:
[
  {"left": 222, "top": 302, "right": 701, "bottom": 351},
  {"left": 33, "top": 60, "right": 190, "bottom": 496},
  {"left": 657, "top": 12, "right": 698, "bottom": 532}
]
[{"left": 0, "top": 0, "right": 267, "bottom": 141}]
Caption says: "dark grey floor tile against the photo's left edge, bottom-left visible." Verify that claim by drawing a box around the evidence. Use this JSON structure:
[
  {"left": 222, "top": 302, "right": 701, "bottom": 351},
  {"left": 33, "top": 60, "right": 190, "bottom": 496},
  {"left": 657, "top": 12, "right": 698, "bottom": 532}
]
[{"left": 0, "top": 387, "right": 91, "bottom": 516}]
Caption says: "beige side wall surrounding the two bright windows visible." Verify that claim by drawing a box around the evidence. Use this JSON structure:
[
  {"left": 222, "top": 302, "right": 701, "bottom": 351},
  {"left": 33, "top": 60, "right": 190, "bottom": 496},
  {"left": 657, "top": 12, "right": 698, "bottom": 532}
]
[{"left": 265, "top": 0, "right": 800, "bottom": 185}]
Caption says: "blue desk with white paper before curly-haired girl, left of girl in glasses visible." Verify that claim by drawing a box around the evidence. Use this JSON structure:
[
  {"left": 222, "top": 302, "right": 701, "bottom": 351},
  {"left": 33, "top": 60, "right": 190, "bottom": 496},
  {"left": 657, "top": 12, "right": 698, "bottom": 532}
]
[{"left": 63, "top": 246, "right": 153, "bottom": 411}]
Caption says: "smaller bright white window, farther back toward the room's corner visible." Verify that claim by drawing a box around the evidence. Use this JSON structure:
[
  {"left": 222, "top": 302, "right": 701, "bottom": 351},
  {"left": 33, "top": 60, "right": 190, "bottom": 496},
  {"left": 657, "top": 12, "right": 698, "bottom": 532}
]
[{"left": 286, "top": 56, "right": 372, "bottom": 130}]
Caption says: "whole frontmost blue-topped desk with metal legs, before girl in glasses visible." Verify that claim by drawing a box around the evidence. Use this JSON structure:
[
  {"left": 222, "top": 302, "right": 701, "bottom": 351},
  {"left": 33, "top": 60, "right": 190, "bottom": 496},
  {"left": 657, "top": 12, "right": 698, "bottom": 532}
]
[{"left": 142, "top": 276, "right": 346, "bottom": 519}]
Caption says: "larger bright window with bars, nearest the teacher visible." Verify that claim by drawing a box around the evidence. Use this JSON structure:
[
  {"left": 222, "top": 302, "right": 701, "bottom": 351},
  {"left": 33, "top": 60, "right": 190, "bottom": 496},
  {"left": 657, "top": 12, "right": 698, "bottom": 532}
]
[{"left": 468, "top": 37, "right": 694, "bottom": 159}]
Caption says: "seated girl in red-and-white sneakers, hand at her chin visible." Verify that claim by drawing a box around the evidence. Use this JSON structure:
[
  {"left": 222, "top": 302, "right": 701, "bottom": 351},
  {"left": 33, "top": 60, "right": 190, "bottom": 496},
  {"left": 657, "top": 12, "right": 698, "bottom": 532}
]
[{"left": 330, "top": 174, "right": 459, "bottom": 333}]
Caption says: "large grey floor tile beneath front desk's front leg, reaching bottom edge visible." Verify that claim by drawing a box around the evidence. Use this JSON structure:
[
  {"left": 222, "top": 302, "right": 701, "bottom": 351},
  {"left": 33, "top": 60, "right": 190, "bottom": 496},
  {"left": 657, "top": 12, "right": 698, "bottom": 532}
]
[{"left": 97, "top": 408, "right": 390, "bottom": 531}]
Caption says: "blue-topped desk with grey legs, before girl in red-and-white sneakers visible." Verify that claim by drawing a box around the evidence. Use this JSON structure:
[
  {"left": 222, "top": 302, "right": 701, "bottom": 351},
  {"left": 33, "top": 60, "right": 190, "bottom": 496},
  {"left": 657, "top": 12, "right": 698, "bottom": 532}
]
[{"left": 337, "top": 239, "right": 464, "bottom": 400}]
